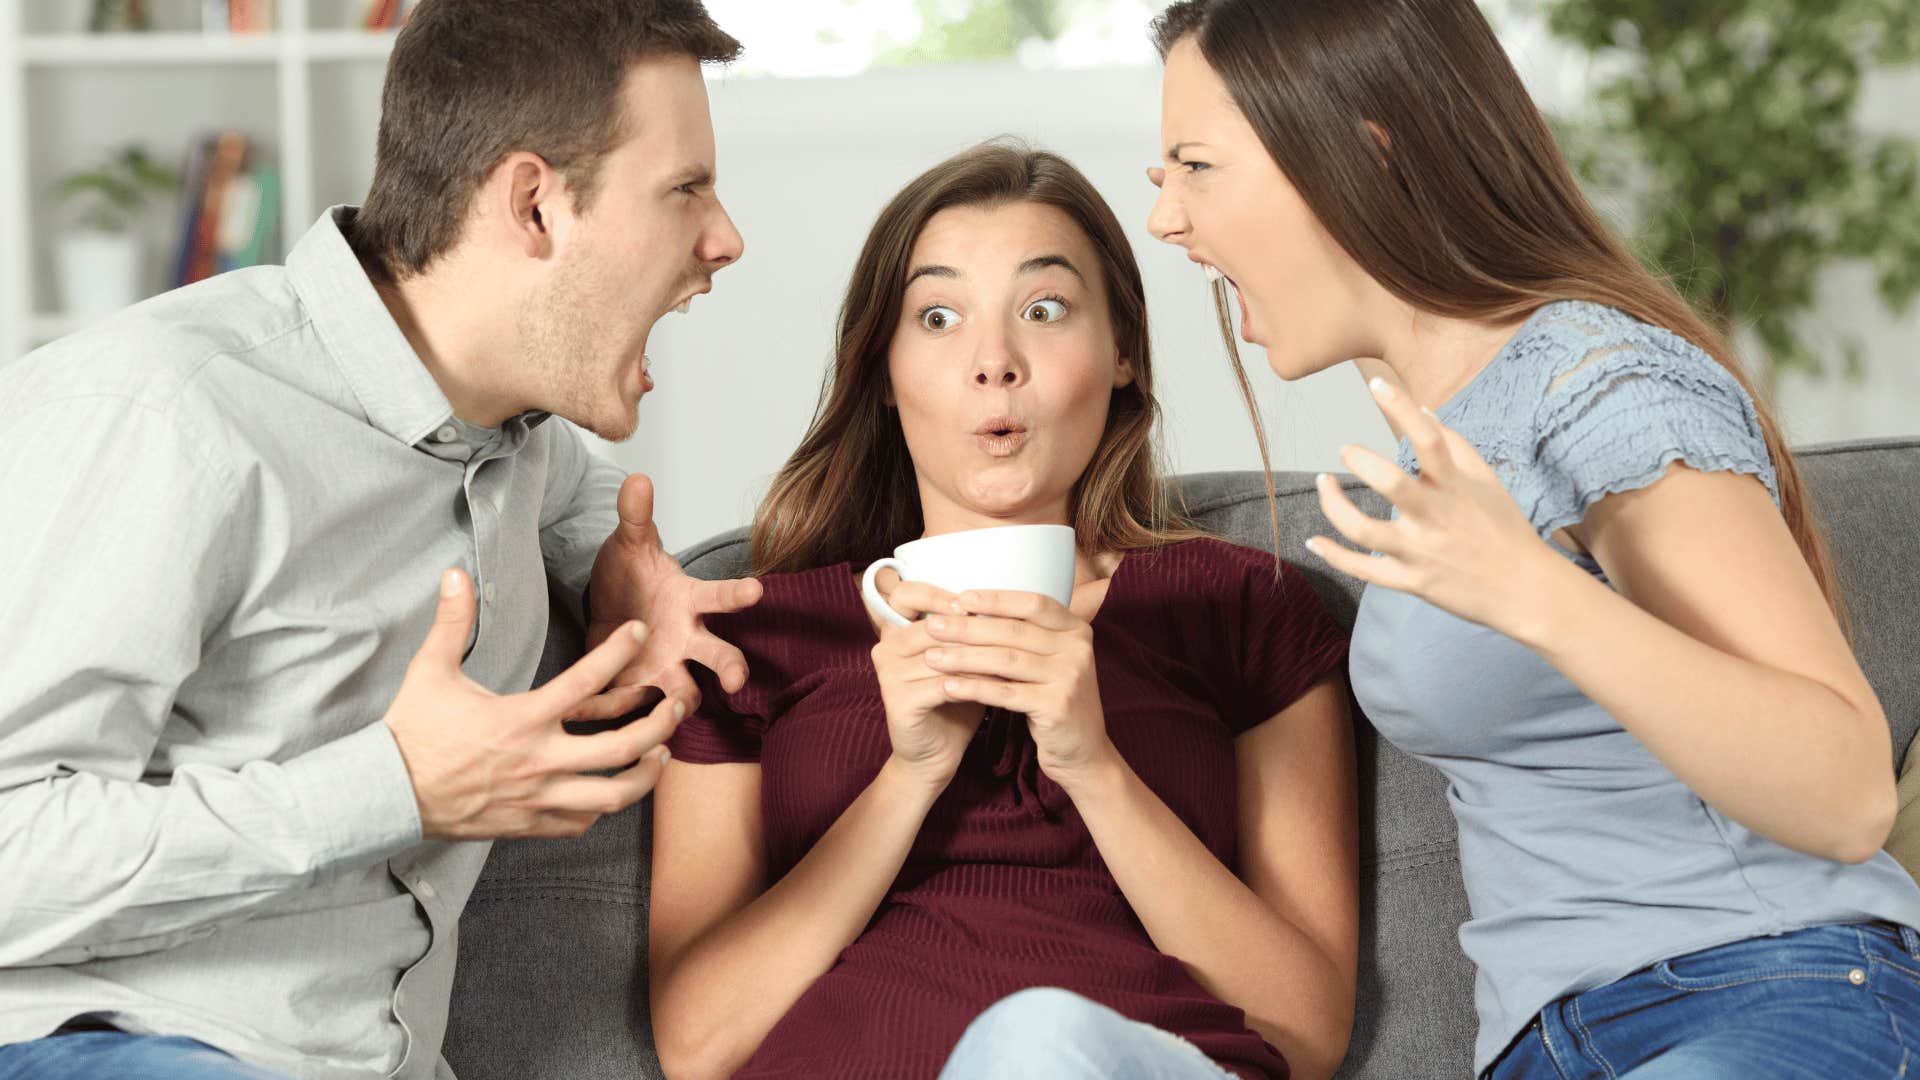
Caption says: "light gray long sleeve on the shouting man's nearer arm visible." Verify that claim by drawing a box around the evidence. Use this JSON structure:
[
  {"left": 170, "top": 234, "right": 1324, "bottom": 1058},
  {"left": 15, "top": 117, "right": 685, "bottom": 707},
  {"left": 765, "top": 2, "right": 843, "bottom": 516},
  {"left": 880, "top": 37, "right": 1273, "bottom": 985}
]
[{"left": 0, "top": 394, "right": 420, "bottom": 967}]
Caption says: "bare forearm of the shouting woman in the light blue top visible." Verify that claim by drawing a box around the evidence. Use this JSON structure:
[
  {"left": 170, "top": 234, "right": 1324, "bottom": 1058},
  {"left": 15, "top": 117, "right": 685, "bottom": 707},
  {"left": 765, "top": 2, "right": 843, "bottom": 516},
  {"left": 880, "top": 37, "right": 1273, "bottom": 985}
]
[{"left": 1507, "top": 563, "right": 1895, "bottom": 861}]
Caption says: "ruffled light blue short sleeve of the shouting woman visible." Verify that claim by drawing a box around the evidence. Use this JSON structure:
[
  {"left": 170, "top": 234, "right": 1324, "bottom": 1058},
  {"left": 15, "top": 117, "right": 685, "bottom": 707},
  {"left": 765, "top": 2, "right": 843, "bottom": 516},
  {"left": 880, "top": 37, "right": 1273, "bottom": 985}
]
[{"left": 1515, "top": 338, "right": 1780, "bottom": 536}]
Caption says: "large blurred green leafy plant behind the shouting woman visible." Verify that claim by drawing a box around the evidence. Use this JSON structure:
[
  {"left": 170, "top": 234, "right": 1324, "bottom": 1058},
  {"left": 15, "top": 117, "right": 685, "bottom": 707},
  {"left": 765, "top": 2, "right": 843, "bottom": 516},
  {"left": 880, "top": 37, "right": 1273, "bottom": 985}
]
[{"left": 1521, "top": 0, "right": 1920, "bottom": 390}]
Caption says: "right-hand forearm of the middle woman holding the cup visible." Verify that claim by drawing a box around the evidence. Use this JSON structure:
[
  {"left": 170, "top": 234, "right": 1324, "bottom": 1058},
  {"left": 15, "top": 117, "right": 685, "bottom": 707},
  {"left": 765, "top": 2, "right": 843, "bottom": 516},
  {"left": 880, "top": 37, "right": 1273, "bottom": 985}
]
[{"left": 1069, "top": 755, "right": 1354, "bottom": 1078}]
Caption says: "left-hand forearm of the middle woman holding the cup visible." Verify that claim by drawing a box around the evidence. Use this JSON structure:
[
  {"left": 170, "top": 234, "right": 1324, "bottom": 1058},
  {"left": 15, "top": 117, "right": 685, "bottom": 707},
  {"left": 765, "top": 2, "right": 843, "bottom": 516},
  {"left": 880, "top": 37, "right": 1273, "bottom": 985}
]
[{"left": 651, "top": 759, "right": 941, "bottom": 1080}]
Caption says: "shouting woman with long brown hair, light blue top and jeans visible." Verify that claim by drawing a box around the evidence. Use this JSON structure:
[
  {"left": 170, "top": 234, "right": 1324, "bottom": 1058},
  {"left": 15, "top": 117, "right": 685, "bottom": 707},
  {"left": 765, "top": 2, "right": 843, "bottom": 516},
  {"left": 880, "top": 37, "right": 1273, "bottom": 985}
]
[{"left": 1150, "top": 0, "right": 1920, "bottom": 1080}]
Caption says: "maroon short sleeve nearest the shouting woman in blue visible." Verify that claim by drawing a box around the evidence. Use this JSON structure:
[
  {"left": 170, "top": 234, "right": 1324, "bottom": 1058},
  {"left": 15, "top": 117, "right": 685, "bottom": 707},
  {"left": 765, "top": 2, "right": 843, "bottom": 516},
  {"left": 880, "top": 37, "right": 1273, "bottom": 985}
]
[{"left": 1223, "top": 548, "right": 1348, "bottom": 736}]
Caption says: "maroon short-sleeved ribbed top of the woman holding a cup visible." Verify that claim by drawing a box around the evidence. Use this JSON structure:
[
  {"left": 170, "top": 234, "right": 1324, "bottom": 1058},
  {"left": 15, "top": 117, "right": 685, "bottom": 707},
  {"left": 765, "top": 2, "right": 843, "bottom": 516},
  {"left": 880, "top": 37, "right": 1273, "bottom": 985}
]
[{"left": 670, "top": 540, "right": 1346, "bottom": 1080}]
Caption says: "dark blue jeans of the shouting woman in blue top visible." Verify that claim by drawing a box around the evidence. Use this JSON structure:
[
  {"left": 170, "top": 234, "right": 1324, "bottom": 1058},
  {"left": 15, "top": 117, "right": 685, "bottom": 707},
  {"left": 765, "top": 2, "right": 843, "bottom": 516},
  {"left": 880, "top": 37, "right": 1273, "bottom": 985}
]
[{"left": 1488, "top": 922, "right": 1920, "bottom": 1080}]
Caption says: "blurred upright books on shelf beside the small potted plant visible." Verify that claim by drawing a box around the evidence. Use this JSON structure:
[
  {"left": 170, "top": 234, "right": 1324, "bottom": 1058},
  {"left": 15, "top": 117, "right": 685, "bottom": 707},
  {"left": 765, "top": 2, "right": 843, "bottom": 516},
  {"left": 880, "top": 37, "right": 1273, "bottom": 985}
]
[{"left": 173, "top": 131, "right": 280, "bottom": 286}]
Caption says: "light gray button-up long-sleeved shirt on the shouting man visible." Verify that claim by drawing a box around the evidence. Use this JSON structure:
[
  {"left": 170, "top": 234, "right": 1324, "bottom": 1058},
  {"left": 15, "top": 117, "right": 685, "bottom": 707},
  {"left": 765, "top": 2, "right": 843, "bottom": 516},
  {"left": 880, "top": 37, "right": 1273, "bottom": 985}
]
[{"left": 0, "top": 208, "right": 622, "bottom": 1078}]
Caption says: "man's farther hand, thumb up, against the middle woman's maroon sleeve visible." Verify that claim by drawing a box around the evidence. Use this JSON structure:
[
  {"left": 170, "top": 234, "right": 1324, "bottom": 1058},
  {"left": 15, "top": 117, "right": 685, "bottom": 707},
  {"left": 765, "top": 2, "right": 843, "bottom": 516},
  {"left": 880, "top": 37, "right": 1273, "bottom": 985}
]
[{"left": 574, "top": 473, "right": 760, "bottom": 721}]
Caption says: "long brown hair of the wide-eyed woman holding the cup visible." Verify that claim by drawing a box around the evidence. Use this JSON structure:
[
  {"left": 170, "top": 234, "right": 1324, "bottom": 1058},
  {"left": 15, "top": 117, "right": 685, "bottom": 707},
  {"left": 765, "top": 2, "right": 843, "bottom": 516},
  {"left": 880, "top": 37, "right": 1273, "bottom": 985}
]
[{"left": 753, "top": 142, "right": 1198, "bottom": 575}]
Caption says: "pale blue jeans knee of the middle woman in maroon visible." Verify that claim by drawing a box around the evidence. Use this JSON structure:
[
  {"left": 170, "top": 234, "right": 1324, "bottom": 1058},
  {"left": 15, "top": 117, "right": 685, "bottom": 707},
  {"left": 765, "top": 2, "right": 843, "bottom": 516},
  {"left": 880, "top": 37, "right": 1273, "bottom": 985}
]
[{"left": 941, "top": 988, "right": 1233, "bottom": 1080}]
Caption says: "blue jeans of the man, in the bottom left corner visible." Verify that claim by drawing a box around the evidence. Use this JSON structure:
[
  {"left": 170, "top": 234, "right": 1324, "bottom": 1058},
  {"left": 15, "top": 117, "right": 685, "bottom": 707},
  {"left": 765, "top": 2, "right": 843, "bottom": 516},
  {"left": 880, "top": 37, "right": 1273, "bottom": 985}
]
[{"left": 0, "top": 1030, "right": 288, "bottom": 1080}]
